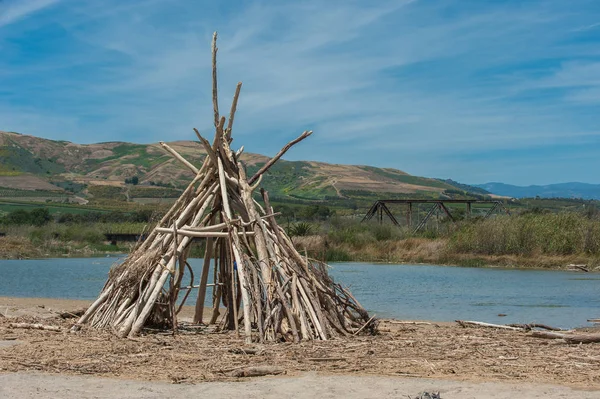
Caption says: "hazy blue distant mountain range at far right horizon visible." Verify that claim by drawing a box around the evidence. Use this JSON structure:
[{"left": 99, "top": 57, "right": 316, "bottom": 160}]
[{"left": 474, "top": 182, "right": 600, "bottom": 200}]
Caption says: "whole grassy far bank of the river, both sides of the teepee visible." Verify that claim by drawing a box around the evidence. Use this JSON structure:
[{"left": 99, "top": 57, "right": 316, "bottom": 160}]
[{"left": 0, "top": 212, "right": 600, "bottom": 269}]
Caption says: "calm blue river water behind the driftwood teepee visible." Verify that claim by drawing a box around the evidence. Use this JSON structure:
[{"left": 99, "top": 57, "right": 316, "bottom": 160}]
[{"left": 0, "top": 257, "right": 600, "bottom": 328}]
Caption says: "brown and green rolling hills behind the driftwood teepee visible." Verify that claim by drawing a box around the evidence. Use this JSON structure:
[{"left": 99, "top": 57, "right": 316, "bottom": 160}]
[{"left": 0, "top": 131, "right": 482, "bottom": 205}]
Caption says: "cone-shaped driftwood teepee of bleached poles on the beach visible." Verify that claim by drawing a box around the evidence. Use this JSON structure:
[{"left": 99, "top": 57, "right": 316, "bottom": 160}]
[{"left": 74, "top": 33, "right": 375, "bottom": 342}]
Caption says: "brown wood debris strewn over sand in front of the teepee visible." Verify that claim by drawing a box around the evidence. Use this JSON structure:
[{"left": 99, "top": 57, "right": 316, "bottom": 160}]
[{"left": 0, "top": 316, "right": 600, "bottom": 388}]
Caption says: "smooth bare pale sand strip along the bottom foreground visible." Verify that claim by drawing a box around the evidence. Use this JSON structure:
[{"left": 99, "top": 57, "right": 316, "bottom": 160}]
[{"left": 0, "top": 373, "right": 600, "bottom": 399}]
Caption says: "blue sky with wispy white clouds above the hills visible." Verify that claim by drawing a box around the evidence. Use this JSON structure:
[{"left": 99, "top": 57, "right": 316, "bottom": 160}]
[{"left": 0, "top": 0, "right": 600, "bottom": 185}]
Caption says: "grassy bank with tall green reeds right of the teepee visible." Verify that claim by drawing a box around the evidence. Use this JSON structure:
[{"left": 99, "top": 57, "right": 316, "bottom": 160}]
[{"left": 294, "top": 212, "right": 600, "bottom": 269}]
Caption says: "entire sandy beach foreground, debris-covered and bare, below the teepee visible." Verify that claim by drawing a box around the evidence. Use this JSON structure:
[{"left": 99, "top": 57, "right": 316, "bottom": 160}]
[{"left": 0, "top": 297, "right": 600, "bottom": 399}]
